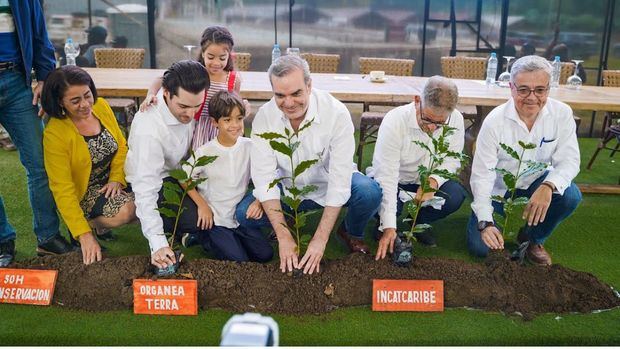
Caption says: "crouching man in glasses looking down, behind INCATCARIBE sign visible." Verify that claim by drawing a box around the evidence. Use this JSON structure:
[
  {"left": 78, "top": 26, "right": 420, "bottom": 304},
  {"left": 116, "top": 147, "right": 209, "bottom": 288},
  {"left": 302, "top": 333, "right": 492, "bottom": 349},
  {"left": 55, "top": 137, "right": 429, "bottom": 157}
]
[{"left": 366, "top": 76, "right": 465, "bottom": 260}]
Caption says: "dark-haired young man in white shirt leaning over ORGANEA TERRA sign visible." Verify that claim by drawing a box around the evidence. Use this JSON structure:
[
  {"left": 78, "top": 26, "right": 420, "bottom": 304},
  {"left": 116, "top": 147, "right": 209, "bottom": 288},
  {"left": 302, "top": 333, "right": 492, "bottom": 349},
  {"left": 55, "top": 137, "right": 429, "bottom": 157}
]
[{"left": 125, "top": 60, "right": 209, "bottom": 268}]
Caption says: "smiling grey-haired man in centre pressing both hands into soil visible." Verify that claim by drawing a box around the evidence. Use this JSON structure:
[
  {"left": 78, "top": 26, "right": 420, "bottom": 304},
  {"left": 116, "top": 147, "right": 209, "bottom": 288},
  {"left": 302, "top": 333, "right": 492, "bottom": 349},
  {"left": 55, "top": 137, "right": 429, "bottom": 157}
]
[{"left": 236, "top": 56, "right": 381, "bottom": 274}]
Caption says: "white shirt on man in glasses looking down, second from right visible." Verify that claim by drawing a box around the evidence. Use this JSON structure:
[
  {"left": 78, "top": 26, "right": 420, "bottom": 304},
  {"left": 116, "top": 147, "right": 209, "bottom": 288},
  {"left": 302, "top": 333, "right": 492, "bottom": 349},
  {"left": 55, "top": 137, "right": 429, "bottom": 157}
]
[{"left": 366, "top": 103, "right": 464, "bottom": 229}]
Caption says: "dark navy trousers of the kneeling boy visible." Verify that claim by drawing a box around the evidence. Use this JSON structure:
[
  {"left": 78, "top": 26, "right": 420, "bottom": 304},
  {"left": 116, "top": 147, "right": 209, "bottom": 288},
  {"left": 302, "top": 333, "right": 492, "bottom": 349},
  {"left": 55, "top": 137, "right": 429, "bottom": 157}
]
[{"left": 198, "top": 225, "right": 273, "bottom": 263}]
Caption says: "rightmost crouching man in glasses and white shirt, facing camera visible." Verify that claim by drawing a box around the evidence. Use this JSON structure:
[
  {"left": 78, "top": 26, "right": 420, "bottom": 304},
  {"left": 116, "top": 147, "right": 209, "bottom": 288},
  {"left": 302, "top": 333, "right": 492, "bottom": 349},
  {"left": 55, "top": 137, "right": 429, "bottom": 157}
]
[{"left": 467, "top": 56, "right": 581, "bottom": 265}]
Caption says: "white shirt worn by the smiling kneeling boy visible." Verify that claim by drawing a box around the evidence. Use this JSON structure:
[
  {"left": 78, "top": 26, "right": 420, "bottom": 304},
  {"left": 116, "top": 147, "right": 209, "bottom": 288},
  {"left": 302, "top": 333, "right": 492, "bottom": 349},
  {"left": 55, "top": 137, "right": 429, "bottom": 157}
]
[{"left": 183, "top": 137, "right": 252, "bottom": 228}]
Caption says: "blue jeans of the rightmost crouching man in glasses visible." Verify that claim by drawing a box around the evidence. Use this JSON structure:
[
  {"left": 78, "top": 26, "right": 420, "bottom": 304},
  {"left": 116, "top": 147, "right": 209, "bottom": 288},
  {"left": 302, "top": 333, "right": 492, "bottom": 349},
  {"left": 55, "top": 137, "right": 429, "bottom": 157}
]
[{"left": 467, "top": 174, "right": 581, "bottom": 257}]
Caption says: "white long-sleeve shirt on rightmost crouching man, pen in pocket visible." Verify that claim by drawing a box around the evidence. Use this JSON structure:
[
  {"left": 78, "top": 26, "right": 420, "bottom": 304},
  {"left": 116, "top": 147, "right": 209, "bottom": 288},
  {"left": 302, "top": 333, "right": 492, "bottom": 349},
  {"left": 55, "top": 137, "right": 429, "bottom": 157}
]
[{"left": 470, "top": 98, "right": 580, "bottom": 222}]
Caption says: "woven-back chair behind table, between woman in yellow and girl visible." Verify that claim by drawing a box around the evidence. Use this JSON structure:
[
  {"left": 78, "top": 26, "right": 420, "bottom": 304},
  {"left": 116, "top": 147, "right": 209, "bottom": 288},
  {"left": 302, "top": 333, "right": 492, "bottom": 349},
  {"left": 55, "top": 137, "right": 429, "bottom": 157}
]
[{"left": 95, "top": 48, "right": 144, "bottom": 135}]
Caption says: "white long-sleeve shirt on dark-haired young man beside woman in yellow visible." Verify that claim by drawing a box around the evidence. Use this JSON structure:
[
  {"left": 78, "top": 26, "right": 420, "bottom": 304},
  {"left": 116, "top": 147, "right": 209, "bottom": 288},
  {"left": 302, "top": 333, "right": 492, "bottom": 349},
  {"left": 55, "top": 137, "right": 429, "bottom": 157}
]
[{"left": 125, "top": 90, "right": 194, "bottom": 253}]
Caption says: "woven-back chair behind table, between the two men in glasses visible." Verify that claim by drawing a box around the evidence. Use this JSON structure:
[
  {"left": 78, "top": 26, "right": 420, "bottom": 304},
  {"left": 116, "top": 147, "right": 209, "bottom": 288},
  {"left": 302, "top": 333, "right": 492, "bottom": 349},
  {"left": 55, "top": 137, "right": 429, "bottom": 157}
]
[{"left": 441, "top": 56, "right": 487, "bottom": 127}]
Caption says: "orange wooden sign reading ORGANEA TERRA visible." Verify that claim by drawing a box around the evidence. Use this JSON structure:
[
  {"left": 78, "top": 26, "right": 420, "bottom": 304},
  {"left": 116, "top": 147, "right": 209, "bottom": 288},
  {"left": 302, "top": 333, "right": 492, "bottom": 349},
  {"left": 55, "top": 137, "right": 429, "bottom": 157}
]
[{"left": 133, "top": 279, "right": 198, "bottom": 315}]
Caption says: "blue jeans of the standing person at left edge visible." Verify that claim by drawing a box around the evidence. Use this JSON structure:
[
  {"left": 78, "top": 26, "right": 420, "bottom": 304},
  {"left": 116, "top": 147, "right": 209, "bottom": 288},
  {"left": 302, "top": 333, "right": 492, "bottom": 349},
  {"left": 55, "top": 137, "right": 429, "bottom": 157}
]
[{"left": 0, "top": 70, "right": 59, "bottom": 244}]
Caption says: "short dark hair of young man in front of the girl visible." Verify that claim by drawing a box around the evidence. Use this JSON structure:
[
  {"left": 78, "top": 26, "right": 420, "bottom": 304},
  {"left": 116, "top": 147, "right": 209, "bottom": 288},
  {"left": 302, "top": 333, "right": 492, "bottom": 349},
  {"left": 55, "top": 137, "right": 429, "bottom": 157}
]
[{"left": 161, "top": 60, "right": 209, "bottom": 97}]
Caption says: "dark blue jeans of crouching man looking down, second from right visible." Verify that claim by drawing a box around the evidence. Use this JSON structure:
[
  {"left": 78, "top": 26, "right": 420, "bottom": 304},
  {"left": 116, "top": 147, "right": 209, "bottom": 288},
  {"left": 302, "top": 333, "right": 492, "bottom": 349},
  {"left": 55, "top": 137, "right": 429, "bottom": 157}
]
[{"left": 396, "top": 180, "right": 465, "bottom": 224}]
